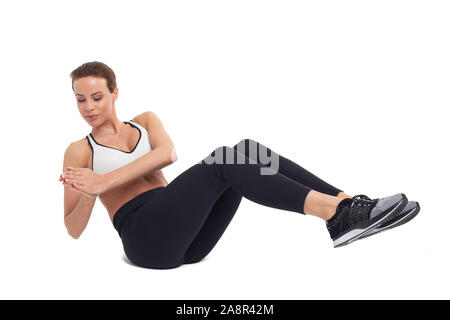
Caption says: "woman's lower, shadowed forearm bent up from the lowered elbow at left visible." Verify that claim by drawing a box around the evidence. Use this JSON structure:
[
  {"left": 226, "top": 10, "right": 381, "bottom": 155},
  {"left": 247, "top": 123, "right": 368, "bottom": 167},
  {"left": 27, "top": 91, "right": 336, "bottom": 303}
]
[{"left": 64, "top": 196, "right": 96, "bottom": 239}]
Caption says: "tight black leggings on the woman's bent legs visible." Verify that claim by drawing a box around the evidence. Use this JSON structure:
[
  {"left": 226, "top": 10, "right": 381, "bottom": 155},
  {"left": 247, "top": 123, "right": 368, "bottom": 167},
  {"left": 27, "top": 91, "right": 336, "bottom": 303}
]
[{"left": 113, "top": 139, "right": 342, "bottom": 269}]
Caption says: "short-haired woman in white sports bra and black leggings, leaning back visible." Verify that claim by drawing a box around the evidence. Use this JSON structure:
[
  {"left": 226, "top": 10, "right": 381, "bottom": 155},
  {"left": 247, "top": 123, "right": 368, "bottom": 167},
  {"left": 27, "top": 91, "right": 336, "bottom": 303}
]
[{"left": 60, "top": 61, "right": 420, "bottom": 269}]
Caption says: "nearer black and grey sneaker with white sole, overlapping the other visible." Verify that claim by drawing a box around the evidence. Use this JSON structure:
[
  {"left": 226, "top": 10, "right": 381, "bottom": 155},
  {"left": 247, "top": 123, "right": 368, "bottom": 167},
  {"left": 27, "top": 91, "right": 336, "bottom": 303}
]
[{"left": 326, "top": 193, "right": 408, "bottom": 248}]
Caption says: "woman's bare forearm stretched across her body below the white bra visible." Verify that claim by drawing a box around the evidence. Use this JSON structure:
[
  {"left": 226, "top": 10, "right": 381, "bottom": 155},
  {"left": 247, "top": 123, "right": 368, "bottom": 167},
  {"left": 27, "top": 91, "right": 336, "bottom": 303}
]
[{"left": 105, "top": 148, "right": 177, "bottom": 191}]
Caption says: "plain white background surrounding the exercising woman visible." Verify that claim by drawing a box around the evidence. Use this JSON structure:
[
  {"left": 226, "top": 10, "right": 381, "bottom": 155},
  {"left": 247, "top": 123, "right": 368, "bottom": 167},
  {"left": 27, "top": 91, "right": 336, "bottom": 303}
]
[{"left": 0, "top": 0, "right": 450, "bottom": 299}]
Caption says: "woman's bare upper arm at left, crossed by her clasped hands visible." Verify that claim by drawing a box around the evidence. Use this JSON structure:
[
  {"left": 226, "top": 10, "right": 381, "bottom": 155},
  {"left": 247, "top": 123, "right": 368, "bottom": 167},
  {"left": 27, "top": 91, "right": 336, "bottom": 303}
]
[{"left": 63, "top": 142, "right": 89, "bottom": 219}]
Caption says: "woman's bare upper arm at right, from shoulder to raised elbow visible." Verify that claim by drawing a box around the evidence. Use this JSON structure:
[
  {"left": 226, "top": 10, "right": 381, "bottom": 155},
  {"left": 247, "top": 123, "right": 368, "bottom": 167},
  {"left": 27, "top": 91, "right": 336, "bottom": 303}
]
[{"left": 136, "top": 111, "right": 176, "bottom": 161}]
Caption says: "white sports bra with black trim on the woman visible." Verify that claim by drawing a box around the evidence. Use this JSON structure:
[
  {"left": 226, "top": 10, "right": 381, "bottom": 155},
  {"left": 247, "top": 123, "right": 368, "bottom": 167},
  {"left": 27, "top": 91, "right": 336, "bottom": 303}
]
[{"left": 86, "top": 120, "right": 152, "bottom": 174}]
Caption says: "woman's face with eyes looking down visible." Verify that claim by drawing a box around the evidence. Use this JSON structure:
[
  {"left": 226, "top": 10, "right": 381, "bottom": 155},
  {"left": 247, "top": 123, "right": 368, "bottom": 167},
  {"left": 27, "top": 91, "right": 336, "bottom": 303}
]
[{"left": 73, "top": 76, "right": 118, "bottom": 127}]
